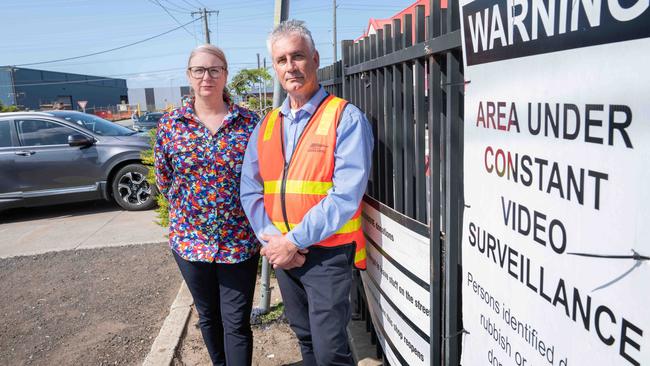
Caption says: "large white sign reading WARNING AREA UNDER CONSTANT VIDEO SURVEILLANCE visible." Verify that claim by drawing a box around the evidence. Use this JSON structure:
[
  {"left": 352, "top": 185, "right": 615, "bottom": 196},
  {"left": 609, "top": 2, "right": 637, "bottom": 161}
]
[{"left": 461, "top": 0, "right": 650, "bottom": 366}]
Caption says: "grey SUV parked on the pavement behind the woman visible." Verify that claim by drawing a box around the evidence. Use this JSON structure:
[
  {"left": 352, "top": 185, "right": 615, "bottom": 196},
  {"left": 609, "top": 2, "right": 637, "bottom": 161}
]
[{"left": 0, "top": 111, "right": 156, "bottom": 210}]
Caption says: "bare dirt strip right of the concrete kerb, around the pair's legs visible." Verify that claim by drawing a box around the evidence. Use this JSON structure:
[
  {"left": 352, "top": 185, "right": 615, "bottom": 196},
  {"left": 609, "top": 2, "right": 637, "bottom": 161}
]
[{"left": 172, "top": 277, "right": 302, "bottom": 366}]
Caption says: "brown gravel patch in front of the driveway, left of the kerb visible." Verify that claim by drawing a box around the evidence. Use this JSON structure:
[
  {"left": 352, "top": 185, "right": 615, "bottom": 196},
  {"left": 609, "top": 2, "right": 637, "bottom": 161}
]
[{"left": 0, "top": 244, "right": 181, "bottom": 365}]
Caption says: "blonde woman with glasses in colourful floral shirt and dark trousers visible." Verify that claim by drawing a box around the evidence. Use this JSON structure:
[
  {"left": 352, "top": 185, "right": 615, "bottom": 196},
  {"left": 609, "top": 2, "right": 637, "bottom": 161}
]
[{"left": 154, "top": 45, "right": 260, "bottom": 365}]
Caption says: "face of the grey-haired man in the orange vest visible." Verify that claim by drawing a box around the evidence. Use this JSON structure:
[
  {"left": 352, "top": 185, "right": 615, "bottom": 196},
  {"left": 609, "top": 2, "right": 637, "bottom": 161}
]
[{"left": 271, "top": 34, "right": 319, "bottom": 98}]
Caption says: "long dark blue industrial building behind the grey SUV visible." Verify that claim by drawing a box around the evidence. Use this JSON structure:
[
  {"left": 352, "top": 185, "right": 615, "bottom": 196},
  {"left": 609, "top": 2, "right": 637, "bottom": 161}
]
[{"left": 0, "top": 66, "right": 129, "bottom": 111}]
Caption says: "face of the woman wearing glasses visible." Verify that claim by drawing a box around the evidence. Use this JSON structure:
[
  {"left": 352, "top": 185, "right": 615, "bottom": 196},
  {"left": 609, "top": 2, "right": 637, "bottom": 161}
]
[{"left": 187, "top": 52, "right": 228, "bottom": 98}]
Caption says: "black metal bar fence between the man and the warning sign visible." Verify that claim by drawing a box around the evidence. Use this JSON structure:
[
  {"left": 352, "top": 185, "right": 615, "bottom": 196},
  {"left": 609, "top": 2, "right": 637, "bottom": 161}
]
[{"left": 319, "top": 0, "right": 465, "bottom": 365}]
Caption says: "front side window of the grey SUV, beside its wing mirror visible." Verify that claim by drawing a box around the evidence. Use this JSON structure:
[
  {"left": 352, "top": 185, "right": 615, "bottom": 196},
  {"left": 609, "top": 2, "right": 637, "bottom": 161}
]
[{"left": 17, "top": 119, "right": 79, "bottom": 146}]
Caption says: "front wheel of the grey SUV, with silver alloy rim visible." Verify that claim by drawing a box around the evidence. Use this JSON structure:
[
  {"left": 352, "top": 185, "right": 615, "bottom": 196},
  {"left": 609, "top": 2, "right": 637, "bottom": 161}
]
[{"left": 112, "top": 164, "right": 156, "bottom": 211}]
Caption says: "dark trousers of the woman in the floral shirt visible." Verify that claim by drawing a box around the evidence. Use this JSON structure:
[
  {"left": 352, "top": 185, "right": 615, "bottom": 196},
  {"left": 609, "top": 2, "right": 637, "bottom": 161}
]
[{"left": 172, "top": 250, "right": 260, "bottom": 366}]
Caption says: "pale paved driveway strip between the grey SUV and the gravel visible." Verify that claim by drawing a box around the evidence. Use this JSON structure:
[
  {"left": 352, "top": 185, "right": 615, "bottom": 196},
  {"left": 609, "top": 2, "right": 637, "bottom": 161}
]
[{"left": 0, "top": 201, "right": 167, "bottom": 258}]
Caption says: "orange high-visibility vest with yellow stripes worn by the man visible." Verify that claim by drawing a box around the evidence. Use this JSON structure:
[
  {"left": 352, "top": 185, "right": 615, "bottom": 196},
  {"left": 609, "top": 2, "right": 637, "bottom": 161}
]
[{"left": 257, "top": 95, "right": 366, "bottom": 269}]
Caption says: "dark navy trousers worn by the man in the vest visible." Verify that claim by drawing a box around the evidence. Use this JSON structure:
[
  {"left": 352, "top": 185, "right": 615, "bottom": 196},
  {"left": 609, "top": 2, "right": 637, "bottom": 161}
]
[{"left": 275, "top": 244, "right": 355, "bottom": 366}]
